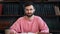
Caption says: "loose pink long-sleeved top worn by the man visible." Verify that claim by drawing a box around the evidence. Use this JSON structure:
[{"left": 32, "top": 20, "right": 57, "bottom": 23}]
[{"left": 10, "top": 16, "right": 49, "bottom": 33}]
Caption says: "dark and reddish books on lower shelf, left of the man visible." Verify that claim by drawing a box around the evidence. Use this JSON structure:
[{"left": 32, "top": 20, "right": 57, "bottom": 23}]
[{"left": 0, "top": 17, "right": 18, "bottom": 30}]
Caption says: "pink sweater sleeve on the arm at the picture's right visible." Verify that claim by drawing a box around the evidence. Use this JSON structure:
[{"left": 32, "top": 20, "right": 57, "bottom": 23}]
[{"left": 38, "top": 17, "right": 49, "bottom": 33}]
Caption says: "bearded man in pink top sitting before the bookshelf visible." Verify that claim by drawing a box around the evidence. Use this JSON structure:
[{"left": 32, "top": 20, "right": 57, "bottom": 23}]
[{"left": 10, "top": 2, "right": 49, "bottom": 33}]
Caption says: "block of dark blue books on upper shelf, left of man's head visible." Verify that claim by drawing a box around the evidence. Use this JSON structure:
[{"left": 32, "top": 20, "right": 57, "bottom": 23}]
[{"left": 3, "top": 4, "right": 19, "bottom": 15}]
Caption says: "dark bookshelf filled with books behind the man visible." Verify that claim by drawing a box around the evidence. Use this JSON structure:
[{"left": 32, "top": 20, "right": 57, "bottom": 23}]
[{"left": 0, "top": 0, "right": 60, "bottom": 32}]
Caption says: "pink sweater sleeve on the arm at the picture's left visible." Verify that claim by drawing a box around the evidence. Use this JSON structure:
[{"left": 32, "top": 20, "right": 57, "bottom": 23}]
[{"left": 10, "top": 19, "right": 21, "bottom": 33}]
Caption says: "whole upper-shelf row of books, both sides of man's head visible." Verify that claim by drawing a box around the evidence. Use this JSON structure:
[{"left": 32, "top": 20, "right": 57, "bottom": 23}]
[{"left": 0, "top": 3, "right": 59, "bottom": 16}]
